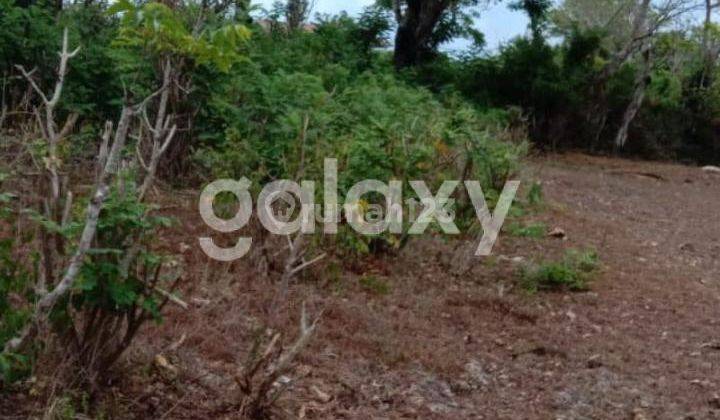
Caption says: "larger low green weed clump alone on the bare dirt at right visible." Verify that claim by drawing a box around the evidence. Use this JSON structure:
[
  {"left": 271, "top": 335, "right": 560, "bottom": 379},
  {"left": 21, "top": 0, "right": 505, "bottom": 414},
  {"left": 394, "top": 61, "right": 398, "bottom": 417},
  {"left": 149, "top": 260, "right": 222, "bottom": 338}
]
[{"left": 520, "top": 250, "right": 600, "bottom": 293}]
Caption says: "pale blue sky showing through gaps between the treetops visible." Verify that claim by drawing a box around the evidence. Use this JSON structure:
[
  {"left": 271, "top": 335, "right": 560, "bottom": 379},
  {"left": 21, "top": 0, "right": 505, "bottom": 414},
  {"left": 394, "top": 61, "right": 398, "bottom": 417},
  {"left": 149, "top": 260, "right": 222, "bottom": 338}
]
[{"left": 254, "top": 0, "right": 528, "bottom": 50}]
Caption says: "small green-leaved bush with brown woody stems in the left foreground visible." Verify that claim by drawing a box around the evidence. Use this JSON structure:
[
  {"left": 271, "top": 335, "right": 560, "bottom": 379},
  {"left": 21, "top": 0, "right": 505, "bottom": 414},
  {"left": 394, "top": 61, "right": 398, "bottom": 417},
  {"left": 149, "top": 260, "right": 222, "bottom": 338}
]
[{"left": 63, "top": 177, "right": 180, "bottom": 380}]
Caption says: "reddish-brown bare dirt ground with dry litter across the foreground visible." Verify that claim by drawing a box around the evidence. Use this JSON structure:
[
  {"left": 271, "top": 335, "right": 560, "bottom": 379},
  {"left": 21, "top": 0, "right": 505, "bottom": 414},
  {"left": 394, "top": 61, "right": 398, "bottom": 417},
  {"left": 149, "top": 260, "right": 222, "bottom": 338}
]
[{"left": 0, "top": 155, "right": 720, "bottom": 420}]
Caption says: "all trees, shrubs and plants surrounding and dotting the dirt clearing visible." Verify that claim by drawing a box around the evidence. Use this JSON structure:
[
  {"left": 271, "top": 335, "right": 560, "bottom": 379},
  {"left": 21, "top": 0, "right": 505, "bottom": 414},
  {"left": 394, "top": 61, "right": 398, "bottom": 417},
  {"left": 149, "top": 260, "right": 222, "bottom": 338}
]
[{"left": 0, "top": 0, "right": 720, "bottom": 417}]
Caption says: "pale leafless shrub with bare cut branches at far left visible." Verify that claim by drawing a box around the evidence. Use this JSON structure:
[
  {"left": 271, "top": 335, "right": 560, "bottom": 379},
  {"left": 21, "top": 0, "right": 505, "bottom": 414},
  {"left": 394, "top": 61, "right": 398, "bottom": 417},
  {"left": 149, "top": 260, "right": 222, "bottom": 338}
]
[{"left": 3, "top": 26, "right": 181, "bottom": 384}]
